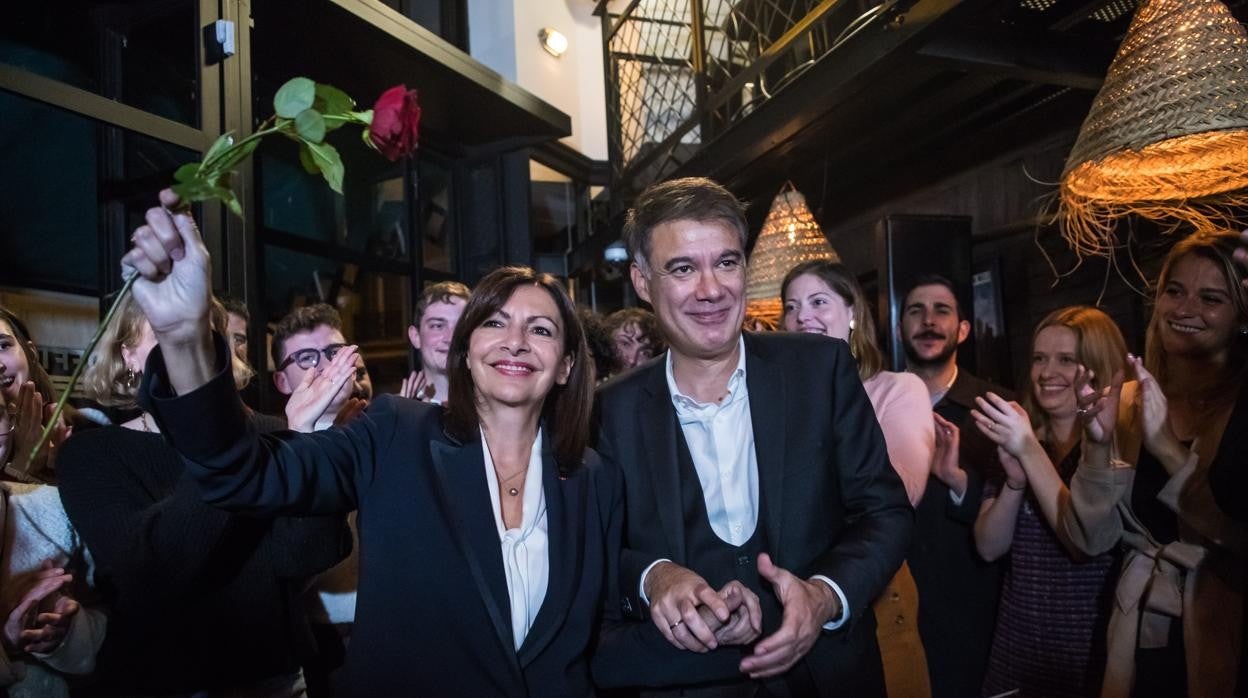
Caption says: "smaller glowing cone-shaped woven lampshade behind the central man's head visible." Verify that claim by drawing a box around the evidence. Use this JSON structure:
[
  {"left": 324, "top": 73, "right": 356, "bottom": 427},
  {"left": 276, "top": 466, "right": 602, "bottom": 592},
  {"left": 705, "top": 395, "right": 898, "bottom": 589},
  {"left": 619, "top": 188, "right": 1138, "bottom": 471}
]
[{"left": 745, "top": 184, "right": 840, "bottom": 323}]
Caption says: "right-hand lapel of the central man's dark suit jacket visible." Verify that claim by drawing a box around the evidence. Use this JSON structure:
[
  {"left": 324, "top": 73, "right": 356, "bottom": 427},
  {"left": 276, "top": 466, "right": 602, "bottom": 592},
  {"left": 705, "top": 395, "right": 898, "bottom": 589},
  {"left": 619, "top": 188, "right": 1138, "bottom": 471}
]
[{"left": 745, "top": 333, "right": 787, "bottom": 549}]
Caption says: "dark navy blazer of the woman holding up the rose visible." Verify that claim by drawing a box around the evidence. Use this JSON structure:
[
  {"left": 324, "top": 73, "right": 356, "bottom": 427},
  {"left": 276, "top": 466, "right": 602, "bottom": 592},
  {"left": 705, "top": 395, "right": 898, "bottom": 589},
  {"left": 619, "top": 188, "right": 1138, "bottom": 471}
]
[{"left": 145, "top": 338, "right": 622, "bottom": 696}]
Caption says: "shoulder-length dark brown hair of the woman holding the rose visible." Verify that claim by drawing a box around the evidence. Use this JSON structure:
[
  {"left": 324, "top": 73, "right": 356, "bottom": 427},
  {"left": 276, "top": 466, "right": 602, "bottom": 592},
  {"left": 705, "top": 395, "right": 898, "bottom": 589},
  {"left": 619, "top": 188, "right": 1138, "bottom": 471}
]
[{"left": 447, "top": 267, "right": 594, "bottom": 474}]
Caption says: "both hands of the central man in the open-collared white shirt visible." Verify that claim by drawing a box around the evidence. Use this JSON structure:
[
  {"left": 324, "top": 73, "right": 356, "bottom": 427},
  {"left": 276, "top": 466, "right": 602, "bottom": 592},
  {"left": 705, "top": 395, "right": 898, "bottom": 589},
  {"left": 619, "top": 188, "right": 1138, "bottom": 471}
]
[{"left": 645, "top": 553, "right": 841, "bottom": 678}]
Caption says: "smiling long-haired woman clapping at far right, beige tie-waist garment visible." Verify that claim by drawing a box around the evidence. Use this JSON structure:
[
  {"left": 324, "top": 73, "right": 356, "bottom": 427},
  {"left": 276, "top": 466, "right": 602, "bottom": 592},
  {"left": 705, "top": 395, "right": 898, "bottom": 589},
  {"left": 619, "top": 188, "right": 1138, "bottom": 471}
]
[{"left": 1062, "top": 232, "right": 1248, "bottom": 698}]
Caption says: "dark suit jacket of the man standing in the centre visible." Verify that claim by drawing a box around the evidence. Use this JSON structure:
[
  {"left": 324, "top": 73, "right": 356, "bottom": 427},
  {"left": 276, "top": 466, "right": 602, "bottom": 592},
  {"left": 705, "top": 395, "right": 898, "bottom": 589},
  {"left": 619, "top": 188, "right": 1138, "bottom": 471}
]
[{"left": 593, "top": 333, "right": 914, "bottom": 696}]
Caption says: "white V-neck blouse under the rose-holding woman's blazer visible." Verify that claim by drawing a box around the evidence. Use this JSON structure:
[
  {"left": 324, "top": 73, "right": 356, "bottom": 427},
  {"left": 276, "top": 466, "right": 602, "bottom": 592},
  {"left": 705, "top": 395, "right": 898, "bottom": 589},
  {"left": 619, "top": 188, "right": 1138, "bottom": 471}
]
[{"left": 480, "top": 430, "right": 550, "bottom": 649}]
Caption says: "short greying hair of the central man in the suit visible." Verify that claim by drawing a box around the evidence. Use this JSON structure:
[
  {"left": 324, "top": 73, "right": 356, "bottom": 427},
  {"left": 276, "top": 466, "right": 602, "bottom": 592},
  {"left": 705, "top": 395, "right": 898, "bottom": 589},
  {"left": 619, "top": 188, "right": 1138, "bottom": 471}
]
[{"left": 624, "top": 177, "right": 749, "bottom": 270}]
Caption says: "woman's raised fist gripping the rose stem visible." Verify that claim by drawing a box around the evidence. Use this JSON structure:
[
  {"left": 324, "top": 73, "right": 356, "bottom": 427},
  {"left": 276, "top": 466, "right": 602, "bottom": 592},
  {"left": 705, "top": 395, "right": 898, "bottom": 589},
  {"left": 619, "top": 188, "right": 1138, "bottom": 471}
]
[{"left": 121, "top": 189, "right": 212, "bottom": 345}]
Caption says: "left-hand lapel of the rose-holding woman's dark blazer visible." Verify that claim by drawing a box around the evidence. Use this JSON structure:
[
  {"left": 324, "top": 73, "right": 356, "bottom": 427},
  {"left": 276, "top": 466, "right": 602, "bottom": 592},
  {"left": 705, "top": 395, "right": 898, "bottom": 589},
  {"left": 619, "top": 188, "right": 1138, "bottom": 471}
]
[{"left": 432, "top": 441, "right": 524, "bottom": 683}]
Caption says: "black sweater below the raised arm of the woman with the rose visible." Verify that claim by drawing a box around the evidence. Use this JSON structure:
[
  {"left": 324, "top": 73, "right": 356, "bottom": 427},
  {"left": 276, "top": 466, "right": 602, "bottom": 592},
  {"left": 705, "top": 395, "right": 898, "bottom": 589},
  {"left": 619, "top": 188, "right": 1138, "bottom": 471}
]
[{"left": 57, "top": 427, "right": 351, "bottom": 694}]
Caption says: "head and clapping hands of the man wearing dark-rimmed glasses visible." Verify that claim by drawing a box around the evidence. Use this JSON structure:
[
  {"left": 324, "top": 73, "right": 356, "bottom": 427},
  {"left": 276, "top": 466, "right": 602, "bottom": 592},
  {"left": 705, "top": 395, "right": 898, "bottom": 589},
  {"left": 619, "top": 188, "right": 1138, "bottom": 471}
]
[{"left": 272, "top": 303, "right": 373, "bottom": 431}]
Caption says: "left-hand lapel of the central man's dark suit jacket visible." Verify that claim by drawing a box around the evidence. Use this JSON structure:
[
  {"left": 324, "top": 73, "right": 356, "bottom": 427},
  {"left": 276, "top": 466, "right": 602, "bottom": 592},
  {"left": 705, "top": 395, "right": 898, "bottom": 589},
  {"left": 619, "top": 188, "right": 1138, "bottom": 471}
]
[{"left": 636, "top": 361, "right": 685, "bottom": 564}]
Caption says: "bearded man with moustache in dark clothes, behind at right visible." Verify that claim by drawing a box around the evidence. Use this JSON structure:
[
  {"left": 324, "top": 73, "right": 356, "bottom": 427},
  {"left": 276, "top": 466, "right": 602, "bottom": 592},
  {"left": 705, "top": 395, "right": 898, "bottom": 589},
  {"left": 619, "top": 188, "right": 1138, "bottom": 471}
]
[{"left": 901, "top": 275, "right": 1012, "bottom": 698}]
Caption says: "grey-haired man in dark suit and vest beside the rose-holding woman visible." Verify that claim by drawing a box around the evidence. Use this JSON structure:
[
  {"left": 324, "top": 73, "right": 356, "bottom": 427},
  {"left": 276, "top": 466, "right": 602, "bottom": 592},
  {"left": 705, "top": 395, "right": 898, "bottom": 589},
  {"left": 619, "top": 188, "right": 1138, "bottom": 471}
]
[{"left": 593, "top": 179, "right": 914, "bottom": 696}]
